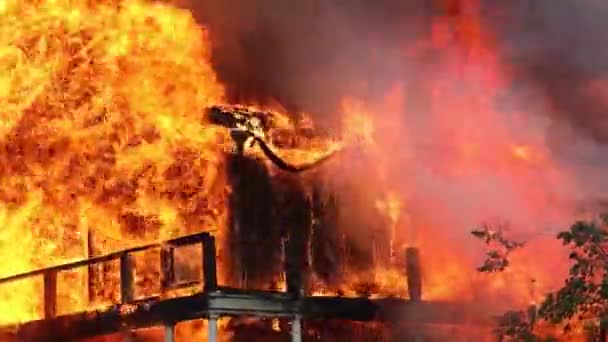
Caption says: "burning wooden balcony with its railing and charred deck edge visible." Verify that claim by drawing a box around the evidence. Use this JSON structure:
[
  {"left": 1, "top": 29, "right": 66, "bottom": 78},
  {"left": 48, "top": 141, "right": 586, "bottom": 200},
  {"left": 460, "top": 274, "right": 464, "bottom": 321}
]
[{"left": 0, "top": 233, "right": 488, "bottom": 342}]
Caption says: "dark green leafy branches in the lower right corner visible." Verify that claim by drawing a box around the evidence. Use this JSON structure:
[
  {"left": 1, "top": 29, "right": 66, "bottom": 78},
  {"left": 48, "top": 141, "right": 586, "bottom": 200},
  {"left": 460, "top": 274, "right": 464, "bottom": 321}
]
[{"left": 471, "top": 215, "right": 608, "bottom": 341}]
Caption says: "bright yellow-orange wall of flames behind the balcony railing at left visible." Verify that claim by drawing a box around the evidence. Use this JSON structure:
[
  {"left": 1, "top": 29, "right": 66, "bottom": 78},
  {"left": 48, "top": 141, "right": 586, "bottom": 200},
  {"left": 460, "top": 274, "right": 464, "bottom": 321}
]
[{"left": 0, "top": 0, "right": 226, "bottom": 323}]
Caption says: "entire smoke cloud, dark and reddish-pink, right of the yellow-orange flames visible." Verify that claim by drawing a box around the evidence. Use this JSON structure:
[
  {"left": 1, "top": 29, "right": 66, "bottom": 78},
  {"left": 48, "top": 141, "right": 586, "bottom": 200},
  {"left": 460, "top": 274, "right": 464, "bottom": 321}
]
[{"left": 183, "top": 0, "right": 608, "bottom": 306}]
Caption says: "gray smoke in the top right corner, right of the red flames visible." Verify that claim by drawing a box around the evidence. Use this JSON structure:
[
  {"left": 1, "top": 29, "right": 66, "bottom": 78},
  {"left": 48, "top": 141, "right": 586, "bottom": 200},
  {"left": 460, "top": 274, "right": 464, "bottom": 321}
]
[{"left": 496, "top": 0, "right": 608, "bottom": 143}]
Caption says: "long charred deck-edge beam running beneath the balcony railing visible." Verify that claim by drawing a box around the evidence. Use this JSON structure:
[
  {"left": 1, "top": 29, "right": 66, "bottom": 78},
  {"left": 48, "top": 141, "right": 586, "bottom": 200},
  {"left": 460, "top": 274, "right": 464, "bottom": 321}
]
[{"left": 0, "top": 289, "right": 491, "bottom": 342}]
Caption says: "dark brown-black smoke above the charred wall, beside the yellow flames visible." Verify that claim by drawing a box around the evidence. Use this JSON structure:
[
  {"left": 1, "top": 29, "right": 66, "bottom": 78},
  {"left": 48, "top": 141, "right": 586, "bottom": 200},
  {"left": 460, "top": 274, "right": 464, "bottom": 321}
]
[{"left": 185, "top": 0, "right": 424, "bottom": 121}]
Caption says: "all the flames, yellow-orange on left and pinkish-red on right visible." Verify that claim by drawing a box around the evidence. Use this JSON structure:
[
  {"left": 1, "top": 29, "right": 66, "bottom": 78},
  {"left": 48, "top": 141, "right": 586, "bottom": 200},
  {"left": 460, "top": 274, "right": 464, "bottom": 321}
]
[{"left": 0, "top": 0, "right": 600, "bottom": 340}]
